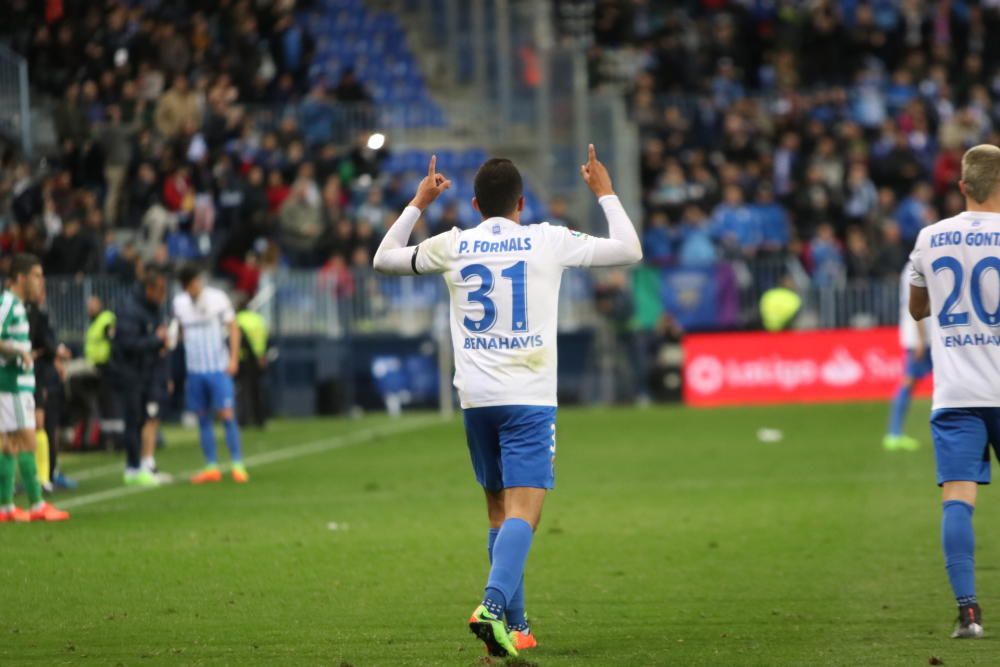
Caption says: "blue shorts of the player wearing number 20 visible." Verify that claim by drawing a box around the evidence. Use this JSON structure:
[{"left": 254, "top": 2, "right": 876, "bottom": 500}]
[{"left": 931, "top": 407, "right": 1000, "bottom": 486}]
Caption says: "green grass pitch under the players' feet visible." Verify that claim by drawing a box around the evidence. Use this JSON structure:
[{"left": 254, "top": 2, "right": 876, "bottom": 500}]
[{"left": 0, "top": 403, "right": 1000, "bottom": 667}]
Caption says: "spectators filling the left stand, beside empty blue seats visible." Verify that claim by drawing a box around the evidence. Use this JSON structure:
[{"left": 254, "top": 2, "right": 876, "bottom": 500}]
[{"left": 0, "top": 0, "right": 414, "bottom": 294}]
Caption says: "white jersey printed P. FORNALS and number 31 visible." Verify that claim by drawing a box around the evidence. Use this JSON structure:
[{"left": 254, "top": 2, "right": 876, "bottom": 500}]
[{"left": 413, "top": 218, "right": 596, "bottom": 408}]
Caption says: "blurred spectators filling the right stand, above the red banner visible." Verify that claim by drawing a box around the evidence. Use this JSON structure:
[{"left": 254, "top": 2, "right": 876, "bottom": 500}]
[{"left": 589, "top": 0, "right": 1000, "bottom": 285}]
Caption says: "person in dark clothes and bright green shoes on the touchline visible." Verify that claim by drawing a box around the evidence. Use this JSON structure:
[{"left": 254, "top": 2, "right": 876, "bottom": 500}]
[{"left": 108, "top": 271, "right": 169, "bottom": 486}]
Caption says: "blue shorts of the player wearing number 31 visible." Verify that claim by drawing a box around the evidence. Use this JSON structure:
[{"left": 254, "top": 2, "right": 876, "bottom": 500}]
[{"left": 463, "top": 405, "right": 556, "bottom": 491}]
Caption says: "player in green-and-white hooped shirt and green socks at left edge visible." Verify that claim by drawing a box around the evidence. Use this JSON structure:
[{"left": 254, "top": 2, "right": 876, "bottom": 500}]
[{"left": 0, "top": 255, "right": 69, "bottom": 523}]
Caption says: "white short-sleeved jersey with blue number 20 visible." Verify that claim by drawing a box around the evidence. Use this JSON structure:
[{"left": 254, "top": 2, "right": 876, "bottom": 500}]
[{"left": 910, "top": 212, "right": 1000, "bottom": 410}]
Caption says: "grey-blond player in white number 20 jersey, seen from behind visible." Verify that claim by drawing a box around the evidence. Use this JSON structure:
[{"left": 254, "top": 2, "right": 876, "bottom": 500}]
[{"left": 910, "top": 144, "right": 1000, "bottom": 638}]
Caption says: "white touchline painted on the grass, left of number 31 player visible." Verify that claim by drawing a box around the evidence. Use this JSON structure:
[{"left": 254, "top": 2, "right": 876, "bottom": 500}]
[{"left": 59, "top": 417, "right": 442, "bottom": 509}]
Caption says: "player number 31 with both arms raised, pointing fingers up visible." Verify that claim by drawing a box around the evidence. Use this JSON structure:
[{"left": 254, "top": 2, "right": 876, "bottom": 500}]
[{"left": 374, "top": 145, "right": 642, "bottom": 656}]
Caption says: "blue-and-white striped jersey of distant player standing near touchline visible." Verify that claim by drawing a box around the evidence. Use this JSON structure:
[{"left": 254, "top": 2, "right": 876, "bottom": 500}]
[{"left": 174, "top": 287, "right": 236, "bottom": 373}]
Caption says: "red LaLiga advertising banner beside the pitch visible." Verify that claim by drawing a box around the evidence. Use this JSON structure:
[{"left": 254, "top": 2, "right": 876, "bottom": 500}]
[{"left": 684, "top": 327, "right": 932, "bottom": 407}]
